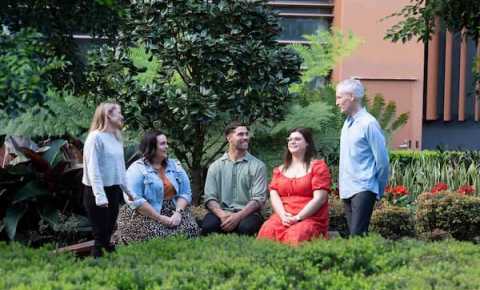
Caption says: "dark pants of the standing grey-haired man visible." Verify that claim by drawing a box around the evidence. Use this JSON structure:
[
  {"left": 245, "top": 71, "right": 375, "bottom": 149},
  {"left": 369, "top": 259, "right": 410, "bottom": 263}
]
[{"left": 343, "top": 191, "right": 376, "bottom": 236}]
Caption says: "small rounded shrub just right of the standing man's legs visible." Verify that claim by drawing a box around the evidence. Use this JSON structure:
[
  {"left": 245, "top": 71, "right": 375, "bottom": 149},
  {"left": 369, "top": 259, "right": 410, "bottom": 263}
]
[{"left": 370, "top": 205, "right": 415, "bottom": 240}]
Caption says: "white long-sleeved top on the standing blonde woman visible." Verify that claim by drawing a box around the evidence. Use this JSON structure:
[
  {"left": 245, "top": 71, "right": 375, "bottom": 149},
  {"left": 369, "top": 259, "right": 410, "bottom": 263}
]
[{"left": 82, "top": 130, "right": 128, "bottom": 206}]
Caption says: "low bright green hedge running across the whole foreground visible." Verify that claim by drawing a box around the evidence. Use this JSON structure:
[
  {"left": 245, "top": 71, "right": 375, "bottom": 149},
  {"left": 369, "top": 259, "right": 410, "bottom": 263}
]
[{"left": 0, "top": 235, "right": 480, "bottom": 290}]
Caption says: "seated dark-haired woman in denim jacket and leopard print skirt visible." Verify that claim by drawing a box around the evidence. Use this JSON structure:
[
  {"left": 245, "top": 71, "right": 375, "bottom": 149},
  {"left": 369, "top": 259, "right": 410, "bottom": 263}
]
[{"left": 114, "top": 131, "right": 200, "bottom": 243}]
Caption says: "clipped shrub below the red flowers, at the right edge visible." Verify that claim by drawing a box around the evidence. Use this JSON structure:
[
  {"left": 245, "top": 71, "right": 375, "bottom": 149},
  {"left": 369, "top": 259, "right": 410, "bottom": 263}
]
[{"left": 416, "top": 191, "right": 480, "bottom": 240}]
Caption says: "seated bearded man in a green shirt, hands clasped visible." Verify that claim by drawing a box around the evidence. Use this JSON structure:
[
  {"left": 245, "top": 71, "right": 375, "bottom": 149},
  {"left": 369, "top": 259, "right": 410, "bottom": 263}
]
[{"left": 202, "top": 122, "right": 267, "bottom": 235}]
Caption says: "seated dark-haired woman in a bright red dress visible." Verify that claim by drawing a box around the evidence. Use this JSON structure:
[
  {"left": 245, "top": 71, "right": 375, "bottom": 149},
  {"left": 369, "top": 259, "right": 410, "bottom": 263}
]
[{"left": 257, "top": 128, "right": 331, "bottom": 245}]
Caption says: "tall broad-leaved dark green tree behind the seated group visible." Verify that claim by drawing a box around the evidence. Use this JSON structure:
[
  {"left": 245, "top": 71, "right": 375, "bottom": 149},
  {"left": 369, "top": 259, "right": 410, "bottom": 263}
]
[{"left": 88, "top": 0, "right": 301, "bottom": 202}]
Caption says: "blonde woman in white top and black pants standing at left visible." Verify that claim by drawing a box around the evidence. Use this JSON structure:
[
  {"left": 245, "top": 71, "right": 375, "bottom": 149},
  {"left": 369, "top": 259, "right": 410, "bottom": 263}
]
[{"left": 82, "top": 103, "right": 133, "bottom": 257}]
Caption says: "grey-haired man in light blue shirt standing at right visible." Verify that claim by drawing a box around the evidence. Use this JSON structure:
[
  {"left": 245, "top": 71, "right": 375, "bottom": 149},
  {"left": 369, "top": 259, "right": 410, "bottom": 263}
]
[{"left": 336, "top": 78, "right": 389, "bottom": 236}]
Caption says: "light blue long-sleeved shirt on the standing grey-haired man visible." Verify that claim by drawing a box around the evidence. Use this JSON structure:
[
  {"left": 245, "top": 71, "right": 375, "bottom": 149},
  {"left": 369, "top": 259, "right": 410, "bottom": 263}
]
[{"left": 339, "top": 109, "right": 389, "bottom": 199}]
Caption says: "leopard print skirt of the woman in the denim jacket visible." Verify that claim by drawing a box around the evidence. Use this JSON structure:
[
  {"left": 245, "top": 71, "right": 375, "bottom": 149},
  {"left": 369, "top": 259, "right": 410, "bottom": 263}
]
[{"left": 112, "top": 200, "right": 200, "bottom": 244}]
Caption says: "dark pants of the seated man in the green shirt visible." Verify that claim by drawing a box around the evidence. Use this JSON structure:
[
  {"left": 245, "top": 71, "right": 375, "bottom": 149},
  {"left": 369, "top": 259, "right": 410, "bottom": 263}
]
[{"left": 202, "top": 212, "right": 263, "bottom": 236}]
